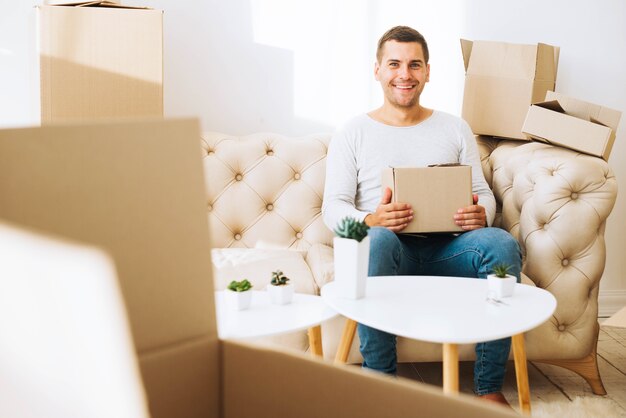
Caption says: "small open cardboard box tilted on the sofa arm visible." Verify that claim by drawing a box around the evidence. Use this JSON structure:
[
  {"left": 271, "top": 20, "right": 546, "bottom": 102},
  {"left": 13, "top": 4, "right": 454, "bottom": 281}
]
[{"left": 522, "top": 91, "right": 622, "bottom": 161}]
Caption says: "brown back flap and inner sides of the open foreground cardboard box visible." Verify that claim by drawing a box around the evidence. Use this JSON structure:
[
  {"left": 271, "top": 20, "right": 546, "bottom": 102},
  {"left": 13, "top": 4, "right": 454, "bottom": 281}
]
[{"left": 0, "top": 120, "right": 517, "bottom": 418}]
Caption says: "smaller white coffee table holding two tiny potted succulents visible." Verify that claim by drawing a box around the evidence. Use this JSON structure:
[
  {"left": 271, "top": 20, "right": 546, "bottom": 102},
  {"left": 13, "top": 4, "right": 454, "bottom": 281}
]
[{"left": 215, "top": 290, "right": 338, "bottom": 356}]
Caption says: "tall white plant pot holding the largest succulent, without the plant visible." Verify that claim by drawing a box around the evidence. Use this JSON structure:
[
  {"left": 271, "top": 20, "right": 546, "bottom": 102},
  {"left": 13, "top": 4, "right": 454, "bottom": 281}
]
[{"left": 333, "top": 237, "right": 370, "bottom": 299}]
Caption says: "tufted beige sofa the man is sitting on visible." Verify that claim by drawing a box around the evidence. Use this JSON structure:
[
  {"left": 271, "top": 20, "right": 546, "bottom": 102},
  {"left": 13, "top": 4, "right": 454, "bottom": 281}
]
[{"left": 202, "top": 132, "right": 617, "bottom": 394}]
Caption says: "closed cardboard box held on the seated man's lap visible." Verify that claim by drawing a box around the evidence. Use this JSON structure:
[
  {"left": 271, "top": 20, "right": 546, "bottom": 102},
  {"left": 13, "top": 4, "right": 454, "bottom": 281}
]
[{"left": 381, "top": 165, "right": 472, "bottom": 233}]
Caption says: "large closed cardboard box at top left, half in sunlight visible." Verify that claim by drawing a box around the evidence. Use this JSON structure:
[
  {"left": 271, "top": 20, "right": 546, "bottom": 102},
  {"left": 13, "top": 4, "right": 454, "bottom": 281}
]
[{"left": 37, "top": 2, "right": 163, "bottom": 124}]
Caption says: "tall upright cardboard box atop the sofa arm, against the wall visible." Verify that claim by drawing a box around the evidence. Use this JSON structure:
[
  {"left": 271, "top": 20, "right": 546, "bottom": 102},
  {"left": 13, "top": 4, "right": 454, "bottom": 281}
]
[{"left": 461, "top": 39, "right": 559, "bottom": 140}]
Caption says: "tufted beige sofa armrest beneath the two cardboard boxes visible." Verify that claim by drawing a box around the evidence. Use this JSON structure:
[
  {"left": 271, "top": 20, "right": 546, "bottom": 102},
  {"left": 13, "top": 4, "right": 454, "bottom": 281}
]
[{"left": 489, "top": 141, "right": 617, "bottom": 358}]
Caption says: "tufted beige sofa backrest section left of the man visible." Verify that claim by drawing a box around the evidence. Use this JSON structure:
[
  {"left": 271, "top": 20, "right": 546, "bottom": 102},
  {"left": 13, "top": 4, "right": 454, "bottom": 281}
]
[{"left": 202, "top": 132, "right": 333, "bottom": 250}]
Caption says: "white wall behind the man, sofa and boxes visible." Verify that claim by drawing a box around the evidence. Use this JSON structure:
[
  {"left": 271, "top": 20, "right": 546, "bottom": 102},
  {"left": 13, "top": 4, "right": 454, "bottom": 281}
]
[{"left": 0, "top": 0, "right": 626, "bottom": 311}]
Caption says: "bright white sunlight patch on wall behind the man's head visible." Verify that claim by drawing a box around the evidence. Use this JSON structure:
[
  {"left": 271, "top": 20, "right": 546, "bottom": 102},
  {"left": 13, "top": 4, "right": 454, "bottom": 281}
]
[{"left": 251, "top": 0, "right": 463, "bottom": 126}]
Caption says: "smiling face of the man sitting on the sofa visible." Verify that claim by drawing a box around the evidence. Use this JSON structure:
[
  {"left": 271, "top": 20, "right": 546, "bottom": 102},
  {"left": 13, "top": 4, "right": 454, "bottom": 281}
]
[{"left": 374, "top": 41, "right": 430, "bottom": 108}]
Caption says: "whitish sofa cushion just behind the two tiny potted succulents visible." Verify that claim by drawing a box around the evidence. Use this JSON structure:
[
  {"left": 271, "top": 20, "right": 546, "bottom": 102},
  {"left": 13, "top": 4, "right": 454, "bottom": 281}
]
[{"left": 211, "top": 248, "right": 317, "bottom": 294}]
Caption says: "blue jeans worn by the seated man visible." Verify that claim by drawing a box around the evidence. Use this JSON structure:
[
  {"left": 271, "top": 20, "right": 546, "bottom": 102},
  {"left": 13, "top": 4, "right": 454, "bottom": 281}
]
[{"left": 358, "top": 227, "right": 522, "bottom": 395}]
